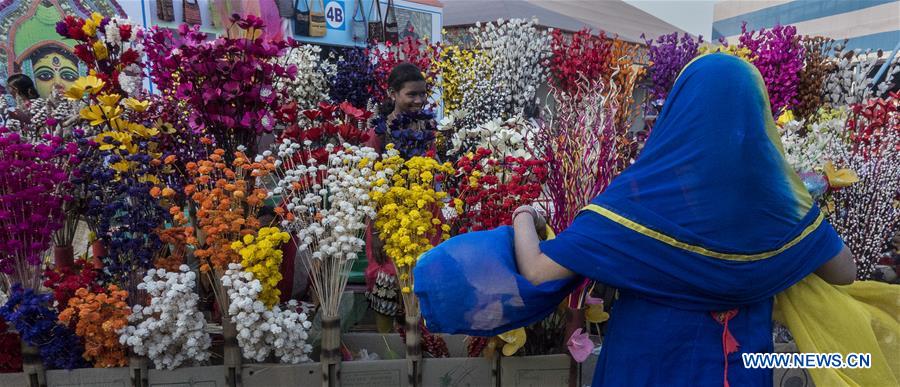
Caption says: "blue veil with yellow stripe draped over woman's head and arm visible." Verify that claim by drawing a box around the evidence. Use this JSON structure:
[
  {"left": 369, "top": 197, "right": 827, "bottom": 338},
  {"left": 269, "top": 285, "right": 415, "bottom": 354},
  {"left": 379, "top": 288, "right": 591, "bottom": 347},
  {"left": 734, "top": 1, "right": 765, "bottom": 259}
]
[{"left": 415, "top": 54, "right": 843, "bottom": 334}]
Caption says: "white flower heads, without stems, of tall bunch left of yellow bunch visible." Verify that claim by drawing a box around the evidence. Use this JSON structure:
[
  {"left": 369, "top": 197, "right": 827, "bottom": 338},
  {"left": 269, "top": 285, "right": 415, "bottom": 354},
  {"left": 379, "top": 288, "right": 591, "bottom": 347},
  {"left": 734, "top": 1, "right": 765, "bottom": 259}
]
[{"left": 273, "top": 140, "right": 378, "bottom": 260}]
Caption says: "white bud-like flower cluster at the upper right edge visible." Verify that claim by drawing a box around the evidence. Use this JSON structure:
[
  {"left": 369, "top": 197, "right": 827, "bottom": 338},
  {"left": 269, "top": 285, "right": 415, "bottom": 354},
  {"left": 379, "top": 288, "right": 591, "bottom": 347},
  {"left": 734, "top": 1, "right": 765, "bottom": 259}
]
[{"left": 825, "top": 45, "right": 900, "bottom": 107}]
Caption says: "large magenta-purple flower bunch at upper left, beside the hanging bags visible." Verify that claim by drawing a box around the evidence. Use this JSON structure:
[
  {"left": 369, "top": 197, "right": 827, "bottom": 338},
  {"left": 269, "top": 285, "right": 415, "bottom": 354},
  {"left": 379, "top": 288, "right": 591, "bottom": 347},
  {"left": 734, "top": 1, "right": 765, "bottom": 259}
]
[{"left": 144, "top": 15, "right": 297, "bottom": 158}]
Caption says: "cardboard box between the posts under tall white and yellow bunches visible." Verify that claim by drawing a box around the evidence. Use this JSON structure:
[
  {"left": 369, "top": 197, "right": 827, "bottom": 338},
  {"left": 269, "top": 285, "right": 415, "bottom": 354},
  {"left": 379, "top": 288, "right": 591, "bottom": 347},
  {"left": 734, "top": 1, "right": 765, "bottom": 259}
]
[{"left": 342, "top": 359, "right": 409, "bottom": 387}]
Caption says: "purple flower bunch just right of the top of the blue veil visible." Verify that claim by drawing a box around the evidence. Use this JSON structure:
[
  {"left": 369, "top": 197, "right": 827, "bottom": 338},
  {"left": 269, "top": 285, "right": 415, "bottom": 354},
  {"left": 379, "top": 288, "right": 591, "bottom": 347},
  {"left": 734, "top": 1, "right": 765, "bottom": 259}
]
[{"left": 739, "top": 23, "right": 805, "bottom": 117}]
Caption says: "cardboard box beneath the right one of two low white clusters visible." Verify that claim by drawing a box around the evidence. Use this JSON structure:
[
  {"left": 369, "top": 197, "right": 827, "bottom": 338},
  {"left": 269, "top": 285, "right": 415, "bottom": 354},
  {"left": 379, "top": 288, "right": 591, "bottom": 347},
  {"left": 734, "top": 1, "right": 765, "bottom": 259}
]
[{"left": 241, "top": 363, "right": 322, "bottom": 387}]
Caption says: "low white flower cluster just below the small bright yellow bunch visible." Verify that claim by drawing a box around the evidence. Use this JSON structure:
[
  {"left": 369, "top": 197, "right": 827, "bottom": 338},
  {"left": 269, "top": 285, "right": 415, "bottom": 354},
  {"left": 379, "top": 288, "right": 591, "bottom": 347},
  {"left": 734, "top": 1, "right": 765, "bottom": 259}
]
[{"left": 222, "top": 263, "right": 312, "bottom": 364}]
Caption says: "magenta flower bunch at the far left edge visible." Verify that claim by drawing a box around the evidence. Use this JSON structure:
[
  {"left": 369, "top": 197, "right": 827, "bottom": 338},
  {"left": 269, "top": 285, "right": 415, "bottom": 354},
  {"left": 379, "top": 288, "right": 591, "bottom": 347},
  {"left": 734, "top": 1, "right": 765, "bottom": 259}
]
[{"left": 0, "top": 127, "right": 75, "bottom": 289}]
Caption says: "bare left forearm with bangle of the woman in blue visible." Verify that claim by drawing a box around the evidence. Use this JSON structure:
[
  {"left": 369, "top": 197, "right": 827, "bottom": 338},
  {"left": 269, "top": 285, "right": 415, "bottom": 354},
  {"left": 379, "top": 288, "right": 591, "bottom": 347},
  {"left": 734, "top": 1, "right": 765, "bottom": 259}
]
[{"left": 513, "top": 206, "right": 575, "bottom": 285}]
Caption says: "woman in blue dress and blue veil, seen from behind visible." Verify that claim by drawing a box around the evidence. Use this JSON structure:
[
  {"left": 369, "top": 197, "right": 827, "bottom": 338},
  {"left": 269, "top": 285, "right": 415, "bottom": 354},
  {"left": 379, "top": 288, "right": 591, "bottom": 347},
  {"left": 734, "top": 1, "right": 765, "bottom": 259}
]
[{"left": 414, "top": 54, "right": 856, "bottom": 386}]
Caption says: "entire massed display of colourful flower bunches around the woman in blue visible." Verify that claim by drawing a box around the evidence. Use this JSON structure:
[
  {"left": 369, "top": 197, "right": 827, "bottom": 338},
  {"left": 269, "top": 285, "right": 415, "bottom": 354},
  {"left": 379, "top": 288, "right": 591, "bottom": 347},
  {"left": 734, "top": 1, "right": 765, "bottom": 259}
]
[{"left": 0, "top": 8, "right": 900, "bottom": 386}]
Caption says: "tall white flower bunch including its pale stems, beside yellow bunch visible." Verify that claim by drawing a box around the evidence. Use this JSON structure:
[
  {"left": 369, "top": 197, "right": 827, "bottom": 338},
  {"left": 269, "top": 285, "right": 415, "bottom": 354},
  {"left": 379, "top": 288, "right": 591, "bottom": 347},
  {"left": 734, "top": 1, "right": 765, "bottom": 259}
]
[{"left": 271, "top": 140, "right": 378, "bottom": 318}]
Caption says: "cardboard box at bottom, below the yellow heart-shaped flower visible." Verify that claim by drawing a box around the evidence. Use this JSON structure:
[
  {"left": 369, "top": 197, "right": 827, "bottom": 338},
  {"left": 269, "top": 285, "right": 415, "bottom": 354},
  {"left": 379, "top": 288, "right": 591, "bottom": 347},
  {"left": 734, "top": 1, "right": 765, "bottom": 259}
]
[{"left": 500, "top": 355, "right": 569, "bottom": 387}]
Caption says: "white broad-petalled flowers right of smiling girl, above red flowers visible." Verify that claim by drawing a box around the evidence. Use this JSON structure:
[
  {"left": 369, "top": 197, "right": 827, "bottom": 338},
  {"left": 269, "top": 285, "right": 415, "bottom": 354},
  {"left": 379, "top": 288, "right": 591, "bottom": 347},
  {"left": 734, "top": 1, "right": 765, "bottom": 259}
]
[{"left": 438, "top": 114, "right": 536, "bottom": 159}]
